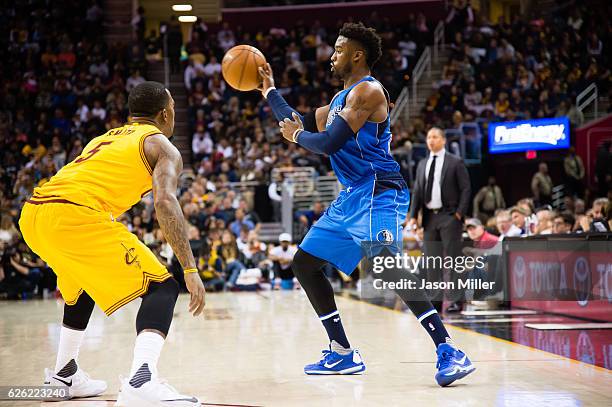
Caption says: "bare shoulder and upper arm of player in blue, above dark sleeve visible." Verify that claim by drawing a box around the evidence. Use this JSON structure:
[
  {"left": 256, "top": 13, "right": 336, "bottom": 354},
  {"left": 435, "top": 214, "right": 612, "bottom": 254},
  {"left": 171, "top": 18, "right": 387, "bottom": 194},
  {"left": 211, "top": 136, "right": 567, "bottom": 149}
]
[{"left": 340, "top": 82, "right": 387, "bottom": 133}]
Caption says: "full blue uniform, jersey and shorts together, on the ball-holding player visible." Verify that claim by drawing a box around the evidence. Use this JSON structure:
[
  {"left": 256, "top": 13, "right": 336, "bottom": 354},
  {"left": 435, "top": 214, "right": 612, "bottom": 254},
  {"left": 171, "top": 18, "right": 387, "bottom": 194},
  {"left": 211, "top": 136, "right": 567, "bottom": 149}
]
[{"left": 300, "top": 76, "right": 410, "bottom": 274}]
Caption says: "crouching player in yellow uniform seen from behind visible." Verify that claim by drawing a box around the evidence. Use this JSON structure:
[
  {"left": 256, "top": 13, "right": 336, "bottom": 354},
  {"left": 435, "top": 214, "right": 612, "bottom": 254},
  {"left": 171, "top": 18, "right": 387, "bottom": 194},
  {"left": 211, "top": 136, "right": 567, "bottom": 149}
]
[{"left": 19, "top": 82, "right": 205, "bottom": 406}]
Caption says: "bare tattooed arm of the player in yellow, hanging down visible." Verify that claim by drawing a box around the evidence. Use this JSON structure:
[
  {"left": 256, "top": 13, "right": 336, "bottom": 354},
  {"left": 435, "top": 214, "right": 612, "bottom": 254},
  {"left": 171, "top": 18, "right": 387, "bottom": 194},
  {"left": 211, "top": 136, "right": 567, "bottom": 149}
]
[{"left": 144, "top": 134, "right": 206, "bottom": 316}]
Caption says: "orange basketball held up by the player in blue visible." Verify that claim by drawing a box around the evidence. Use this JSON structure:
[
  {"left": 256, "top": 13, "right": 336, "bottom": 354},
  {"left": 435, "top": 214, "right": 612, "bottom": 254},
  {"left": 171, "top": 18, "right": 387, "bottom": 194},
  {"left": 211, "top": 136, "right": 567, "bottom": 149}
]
[{"left": 221, "top": 45, "right": 266, "bottom": 91}]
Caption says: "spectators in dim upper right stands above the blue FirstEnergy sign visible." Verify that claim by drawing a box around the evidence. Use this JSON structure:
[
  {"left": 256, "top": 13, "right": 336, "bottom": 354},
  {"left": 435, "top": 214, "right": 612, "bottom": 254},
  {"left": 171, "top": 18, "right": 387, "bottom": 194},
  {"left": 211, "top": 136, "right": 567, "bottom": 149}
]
[{"left": 396, "top": 1, "right": 612, "bottom": 141}]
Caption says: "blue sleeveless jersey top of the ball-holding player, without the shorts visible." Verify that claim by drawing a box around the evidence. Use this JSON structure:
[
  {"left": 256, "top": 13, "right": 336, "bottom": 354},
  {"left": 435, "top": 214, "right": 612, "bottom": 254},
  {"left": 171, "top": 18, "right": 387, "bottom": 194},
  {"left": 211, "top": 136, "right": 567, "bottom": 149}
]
[{"left": 326, "top": 76, "right": 399, "bottom": 186}]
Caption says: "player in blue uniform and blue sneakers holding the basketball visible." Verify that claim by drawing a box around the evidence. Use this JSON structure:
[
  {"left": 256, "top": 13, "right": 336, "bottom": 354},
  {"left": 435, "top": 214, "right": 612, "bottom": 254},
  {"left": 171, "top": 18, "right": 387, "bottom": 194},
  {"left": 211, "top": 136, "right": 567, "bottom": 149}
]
[{"left": 259, "top": 23, "right": 474, "bottom": 386}]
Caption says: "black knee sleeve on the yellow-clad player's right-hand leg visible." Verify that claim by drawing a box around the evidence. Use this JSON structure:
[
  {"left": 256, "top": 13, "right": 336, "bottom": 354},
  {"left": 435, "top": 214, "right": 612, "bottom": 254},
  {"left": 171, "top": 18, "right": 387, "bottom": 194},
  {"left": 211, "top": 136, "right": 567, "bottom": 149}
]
[{"left": 136, "top": 278, "right": 179, "bottom": 335}]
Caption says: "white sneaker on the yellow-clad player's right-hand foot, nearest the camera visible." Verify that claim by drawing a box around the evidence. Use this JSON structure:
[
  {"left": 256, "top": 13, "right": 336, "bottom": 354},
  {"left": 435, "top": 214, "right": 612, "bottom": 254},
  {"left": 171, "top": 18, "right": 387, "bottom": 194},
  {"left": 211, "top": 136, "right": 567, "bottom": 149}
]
[{"left": 115, "top": 372, "right": 201, "bottom": 407}]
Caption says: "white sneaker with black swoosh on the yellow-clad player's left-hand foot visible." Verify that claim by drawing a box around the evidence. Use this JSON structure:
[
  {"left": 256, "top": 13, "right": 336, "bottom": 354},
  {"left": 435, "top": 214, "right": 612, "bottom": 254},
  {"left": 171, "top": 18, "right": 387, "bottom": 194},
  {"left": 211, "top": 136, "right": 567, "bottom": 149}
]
[{"left": 44, "top": 360, "right": 107, "bottom": 398}]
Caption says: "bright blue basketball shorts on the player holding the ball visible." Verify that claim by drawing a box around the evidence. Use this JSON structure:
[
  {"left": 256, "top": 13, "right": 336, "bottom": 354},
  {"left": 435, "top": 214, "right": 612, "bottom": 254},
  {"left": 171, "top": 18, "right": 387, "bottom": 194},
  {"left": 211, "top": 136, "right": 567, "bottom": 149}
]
[{"left": 299, "top": 173, "right": 410, "bottom": 275}]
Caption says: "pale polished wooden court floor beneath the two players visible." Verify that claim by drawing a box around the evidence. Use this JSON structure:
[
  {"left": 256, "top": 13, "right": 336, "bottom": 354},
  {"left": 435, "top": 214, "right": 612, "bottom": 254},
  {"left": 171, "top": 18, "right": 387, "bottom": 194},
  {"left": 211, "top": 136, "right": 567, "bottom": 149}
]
[{"left": 0, "top": 291, "right": 612, "bottom": 407}]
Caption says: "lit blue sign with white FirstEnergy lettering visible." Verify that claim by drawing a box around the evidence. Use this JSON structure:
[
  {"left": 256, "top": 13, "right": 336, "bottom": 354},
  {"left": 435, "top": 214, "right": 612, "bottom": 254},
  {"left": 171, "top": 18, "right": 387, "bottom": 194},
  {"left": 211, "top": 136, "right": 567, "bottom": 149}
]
[{"left": 489, "top": 117, "right": 570, "bottom": 154}]
